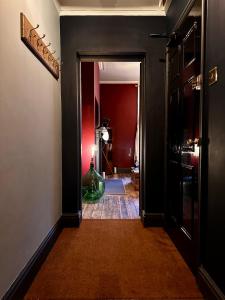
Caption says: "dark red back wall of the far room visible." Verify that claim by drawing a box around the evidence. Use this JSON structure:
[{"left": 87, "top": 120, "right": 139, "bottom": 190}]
[{"left": 100, "top": 84, "right": 138, "bottom": 168}]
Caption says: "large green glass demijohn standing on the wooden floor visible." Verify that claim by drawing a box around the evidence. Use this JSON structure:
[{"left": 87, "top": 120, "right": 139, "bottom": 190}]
[{"left": 82, "top": 158, "right": 105, "bottom": 203}]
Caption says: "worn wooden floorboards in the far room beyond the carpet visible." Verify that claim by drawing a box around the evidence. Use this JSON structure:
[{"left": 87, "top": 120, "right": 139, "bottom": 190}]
[{"left": 82, "top": 174, "right": 140, "bottom": 219}]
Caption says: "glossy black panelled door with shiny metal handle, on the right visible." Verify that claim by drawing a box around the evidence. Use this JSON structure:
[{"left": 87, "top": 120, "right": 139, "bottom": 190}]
[{"left": 166, "top": 2, "right": 201, "bottom": 271}]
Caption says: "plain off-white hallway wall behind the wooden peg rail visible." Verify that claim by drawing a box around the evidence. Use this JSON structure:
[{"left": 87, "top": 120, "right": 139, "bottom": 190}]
[{"left": 0, "top": 0, "right": 61, "bottom": 298}]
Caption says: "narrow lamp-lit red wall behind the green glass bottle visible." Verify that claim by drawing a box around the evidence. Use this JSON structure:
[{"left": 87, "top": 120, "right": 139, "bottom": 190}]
[{"left": 81, "top": 62, "right": 100, "bottom": 175}]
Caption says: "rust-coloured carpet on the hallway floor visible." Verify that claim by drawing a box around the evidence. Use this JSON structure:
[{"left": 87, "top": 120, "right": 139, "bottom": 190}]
[{"left": 25, "top": 220, "right": 203, "bottom": 300}]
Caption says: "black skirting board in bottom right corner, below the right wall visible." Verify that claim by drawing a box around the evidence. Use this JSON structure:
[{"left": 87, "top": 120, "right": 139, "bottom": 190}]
[{"left": 197, "top": 266, "right": 225, "bottom": 300}]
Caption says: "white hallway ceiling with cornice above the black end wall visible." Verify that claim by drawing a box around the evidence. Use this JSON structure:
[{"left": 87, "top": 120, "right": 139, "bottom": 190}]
[{"left": 53, "top": 0, "right": 171, "bottom": 16}]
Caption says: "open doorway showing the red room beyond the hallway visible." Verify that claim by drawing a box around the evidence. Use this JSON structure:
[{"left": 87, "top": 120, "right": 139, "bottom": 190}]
[{"left": 81, "top": 61, "right": 140, "bottom": 219}]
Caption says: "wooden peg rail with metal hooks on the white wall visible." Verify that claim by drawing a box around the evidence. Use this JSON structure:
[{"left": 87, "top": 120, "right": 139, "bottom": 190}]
[{"left": 20, "top": 13, "right": 59, "bottom": 79}]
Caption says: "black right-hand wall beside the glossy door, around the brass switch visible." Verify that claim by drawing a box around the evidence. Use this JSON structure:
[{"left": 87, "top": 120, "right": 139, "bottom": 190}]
[{"left": 168, "top": 0, "right": 225, "bottom": 297}]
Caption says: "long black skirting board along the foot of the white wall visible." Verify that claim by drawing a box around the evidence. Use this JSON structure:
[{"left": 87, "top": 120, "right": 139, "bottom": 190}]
[{"left": 2, "top": 218, "right": 62, "bottom": 300}]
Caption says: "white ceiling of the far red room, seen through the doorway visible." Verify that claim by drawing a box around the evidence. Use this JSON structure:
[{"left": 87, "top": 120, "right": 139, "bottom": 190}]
[{"left": 100, "top": 62, "right": 140, "bottom": 83}]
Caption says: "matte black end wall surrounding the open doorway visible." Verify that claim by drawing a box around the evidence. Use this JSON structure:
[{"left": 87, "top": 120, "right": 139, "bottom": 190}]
[{"left": 60, "top": 16, "right": 166, "bottom": 214}]
